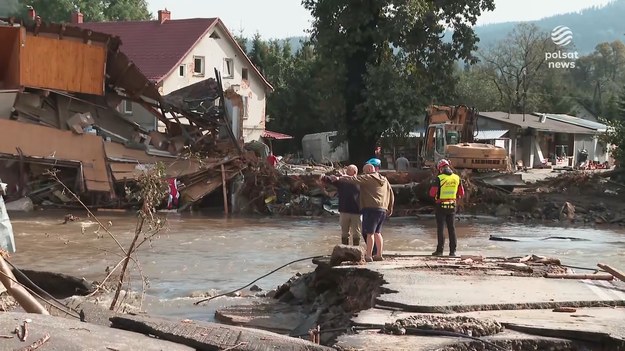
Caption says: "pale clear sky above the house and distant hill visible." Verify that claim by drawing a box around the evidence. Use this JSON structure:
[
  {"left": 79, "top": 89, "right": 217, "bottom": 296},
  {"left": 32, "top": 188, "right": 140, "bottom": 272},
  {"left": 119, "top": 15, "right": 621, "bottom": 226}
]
[{"left": 147, "top": 0, "right": 610, "bottom": 39}]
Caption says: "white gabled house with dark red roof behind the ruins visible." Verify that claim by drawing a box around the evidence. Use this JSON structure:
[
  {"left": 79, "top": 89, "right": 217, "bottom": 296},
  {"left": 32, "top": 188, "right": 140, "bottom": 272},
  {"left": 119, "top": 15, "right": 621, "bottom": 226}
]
[{"left": 72, "top": 9, "right": 273, "bottom": 142}]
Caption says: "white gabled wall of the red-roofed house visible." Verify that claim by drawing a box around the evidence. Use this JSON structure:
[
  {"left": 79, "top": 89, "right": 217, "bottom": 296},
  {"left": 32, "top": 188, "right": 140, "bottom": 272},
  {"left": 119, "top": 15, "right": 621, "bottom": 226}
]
[{"left": 121, "top": 26, "right": 266, "bottom": 142}]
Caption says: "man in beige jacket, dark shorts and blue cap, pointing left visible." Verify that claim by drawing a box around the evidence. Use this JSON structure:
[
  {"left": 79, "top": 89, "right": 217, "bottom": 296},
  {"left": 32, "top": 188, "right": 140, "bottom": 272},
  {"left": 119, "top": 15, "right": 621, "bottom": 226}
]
[{"left": 326, "top": 159, "right": 395, "bottom": 262}]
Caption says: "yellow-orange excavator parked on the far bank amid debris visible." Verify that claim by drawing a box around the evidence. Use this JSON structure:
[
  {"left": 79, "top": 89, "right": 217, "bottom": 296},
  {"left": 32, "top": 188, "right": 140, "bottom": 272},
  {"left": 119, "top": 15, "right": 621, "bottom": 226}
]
[{"left": 421, "top": 105, "right": 508, "bottom": 171}]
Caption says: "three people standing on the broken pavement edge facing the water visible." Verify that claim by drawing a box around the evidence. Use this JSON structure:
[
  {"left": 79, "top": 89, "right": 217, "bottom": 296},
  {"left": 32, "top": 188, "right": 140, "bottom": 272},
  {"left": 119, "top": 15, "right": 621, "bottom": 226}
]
[{"left": 322, "top": 158, "right": 464, "bottom": 262}]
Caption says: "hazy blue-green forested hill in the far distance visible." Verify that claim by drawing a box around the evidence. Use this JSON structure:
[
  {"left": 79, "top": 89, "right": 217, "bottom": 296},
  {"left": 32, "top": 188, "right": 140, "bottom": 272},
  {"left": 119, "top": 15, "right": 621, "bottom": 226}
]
[{"left": 286, "top": 0, "right": 625, "bottom": 55}]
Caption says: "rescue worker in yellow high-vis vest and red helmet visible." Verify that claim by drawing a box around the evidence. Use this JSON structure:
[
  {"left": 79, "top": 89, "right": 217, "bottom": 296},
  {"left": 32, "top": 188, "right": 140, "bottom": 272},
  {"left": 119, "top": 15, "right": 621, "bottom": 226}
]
[{"left": 430, "top": 159, "right": 464, "bottom": 256}]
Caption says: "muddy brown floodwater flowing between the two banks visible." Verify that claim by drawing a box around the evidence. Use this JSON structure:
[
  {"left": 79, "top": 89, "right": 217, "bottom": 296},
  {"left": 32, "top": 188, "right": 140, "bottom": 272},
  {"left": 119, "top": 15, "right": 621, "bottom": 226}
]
[{"left": 6, "top": 211, "right": 625, "bottom": 320}]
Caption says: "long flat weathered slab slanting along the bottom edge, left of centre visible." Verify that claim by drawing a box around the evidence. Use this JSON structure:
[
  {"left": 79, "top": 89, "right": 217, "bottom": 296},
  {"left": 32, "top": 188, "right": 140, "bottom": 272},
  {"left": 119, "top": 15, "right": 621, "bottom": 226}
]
[{"left": 110, "top": 315, "right": 334, "bottom": 351}]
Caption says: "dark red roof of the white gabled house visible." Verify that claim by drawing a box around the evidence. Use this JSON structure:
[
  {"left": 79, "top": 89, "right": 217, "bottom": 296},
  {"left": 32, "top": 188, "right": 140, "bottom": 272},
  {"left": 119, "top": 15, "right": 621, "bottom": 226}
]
[{"left": 72, "top": 18, "right": 273, "bottom": 90}]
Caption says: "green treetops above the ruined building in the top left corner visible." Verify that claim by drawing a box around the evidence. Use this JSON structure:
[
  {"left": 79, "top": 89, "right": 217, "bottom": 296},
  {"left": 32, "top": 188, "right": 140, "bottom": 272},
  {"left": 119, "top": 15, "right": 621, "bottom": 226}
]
[{"left": 14, "top": 0, "right": 152, "bottom": 23}]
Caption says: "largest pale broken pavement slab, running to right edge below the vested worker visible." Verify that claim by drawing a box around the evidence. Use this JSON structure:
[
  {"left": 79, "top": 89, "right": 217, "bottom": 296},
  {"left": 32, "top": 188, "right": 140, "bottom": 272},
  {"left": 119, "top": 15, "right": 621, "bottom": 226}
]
[{"left": 376, "top": 266, "right": 625, "bottom": 313}]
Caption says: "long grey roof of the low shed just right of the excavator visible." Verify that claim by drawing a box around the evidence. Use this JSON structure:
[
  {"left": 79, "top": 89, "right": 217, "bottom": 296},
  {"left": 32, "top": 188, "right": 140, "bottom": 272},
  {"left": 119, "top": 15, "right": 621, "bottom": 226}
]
[{"left": 480, "top": 111, "right": 597, "bottom": 134}]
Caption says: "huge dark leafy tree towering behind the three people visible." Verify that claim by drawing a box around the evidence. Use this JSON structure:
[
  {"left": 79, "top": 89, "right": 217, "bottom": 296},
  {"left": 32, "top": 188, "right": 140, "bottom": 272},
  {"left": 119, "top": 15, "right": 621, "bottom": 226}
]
[{"left": 302, "top": 0, "right": 494, "bottom": 164}]
